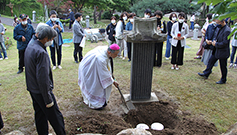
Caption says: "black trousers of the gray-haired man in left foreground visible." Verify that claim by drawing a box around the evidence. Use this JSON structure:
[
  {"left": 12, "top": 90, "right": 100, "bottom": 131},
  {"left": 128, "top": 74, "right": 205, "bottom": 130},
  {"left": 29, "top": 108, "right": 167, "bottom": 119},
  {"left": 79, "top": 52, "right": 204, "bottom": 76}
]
[{"left": 30, "top": 92, "right": 66, "bottom": 135}]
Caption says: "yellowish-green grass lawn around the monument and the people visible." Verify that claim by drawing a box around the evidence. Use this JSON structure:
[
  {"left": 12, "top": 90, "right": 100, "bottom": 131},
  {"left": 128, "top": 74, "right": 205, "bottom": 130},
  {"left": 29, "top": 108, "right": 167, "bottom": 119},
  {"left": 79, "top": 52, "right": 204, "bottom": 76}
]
[{"left": 0, "top": 25, "right": 237, "bottom": 134}]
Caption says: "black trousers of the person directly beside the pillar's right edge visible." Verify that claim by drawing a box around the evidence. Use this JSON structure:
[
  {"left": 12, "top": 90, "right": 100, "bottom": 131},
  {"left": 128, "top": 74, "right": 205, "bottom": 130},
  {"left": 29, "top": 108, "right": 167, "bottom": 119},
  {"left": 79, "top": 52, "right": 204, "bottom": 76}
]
[{"left": 154, "top": 42, "right": 163, "bottom": 67}]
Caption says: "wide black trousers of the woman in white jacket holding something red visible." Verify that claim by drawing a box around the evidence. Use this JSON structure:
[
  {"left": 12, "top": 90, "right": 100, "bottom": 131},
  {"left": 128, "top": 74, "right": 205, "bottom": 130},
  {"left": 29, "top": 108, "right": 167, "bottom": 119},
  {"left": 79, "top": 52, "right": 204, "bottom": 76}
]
[{"left": 171, "top": 42, "right": 184, "bottom": 65}]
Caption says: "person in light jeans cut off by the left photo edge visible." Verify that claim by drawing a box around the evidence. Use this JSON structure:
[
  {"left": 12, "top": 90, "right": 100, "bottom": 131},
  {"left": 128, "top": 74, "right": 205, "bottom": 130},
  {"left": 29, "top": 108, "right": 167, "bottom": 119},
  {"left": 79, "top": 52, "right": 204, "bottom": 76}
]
[{"left": 0, "top": 19, "right": 8, "bottom": 60}]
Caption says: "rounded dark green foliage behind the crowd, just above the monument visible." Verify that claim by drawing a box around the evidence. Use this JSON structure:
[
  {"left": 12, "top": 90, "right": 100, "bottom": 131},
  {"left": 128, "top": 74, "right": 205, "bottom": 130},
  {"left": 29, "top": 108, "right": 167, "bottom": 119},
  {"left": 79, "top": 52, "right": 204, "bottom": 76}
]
[{"left": 130, "top": 0, "right": 201, "bottom": 16}]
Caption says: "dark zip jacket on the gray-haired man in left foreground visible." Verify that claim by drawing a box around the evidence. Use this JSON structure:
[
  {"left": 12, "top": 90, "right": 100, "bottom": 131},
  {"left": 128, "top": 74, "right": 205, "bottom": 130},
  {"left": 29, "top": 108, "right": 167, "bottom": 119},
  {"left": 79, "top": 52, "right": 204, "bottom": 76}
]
[{"left": 24, "top": 40, "right": 53, "bottom": 105}]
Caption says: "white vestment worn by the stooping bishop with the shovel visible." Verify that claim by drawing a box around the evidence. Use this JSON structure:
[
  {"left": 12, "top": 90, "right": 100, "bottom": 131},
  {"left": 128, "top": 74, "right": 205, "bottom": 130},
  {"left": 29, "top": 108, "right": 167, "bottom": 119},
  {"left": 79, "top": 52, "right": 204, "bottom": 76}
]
[{"left": 78, "top": 46, "right": 114, "bottom": 109}]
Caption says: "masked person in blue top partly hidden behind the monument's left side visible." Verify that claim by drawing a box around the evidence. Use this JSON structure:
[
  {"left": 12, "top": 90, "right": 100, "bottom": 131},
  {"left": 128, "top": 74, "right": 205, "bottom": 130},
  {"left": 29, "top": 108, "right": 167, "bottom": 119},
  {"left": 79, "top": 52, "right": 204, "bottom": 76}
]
[{"left": 125, "top": 13, "right": 134, "bottom": 62}]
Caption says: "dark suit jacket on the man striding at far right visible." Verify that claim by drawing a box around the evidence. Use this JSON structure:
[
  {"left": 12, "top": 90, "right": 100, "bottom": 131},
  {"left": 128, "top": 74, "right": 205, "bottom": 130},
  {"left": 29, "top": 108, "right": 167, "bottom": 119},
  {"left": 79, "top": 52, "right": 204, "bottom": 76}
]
[{"left": 213, "top": 25, "right": 231, "bottom": 59}]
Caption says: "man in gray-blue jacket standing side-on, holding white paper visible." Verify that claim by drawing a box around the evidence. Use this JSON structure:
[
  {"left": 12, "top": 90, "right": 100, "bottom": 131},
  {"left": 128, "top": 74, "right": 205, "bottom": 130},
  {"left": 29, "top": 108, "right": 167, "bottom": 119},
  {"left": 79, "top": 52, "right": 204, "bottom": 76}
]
[{"left": 72, "top": 13, "right": 86, "bottom": 63}]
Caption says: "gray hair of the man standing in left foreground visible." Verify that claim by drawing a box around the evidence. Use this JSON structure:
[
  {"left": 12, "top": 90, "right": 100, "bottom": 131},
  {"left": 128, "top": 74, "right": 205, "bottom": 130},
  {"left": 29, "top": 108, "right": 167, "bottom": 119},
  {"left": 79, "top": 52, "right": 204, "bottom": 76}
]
[{"left": 38, "top": 26, "right": 57, "bottom": 40}]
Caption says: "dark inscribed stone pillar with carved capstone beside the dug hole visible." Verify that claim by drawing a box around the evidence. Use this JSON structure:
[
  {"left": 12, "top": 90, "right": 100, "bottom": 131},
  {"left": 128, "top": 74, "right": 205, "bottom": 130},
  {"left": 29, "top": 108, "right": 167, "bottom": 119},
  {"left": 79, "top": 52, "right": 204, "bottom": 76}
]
[{"left": 125, "top": 17, "right": 167, "bottom": 101}]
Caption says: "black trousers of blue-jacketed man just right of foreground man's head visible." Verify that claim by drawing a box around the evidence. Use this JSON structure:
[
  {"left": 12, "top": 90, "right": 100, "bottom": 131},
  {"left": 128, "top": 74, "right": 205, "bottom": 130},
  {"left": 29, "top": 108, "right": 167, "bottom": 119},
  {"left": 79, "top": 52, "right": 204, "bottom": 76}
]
[{"left": 49, "top": 45, "right": 62, "bottom": 66}]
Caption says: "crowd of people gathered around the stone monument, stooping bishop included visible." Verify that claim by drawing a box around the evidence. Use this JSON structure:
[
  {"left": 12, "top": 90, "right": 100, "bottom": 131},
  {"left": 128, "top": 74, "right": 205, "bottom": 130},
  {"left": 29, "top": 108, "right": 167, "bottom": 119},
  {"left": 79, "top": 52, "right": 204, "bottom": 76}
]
[{"left": 0, "top": 9, "right": 237, "bottom": 135}]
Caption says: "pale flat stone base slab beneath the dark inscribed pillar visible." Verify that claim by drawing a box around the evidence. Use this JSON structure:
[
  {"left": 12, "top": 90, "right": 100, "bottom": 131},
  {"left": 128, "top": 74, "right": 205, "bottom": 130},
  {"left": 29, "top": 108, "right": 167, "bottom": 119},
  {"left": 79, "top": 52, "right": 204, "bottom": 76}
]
[{"left": 123, "top": 92, "right": 159, "bottom": 103}]
